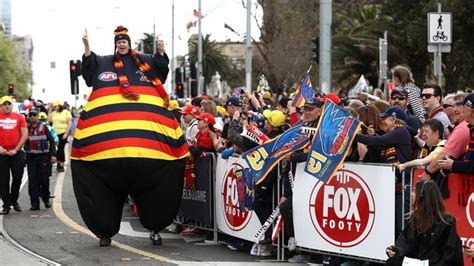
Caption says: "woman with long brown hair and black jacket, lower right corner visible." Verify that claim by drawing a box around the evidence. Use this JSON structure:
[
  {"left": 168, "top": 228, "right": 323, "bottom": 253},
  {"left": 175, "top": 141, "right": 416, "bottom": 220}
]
[{"left": 386, "top": 180, "right": 463, "bottom": 266}]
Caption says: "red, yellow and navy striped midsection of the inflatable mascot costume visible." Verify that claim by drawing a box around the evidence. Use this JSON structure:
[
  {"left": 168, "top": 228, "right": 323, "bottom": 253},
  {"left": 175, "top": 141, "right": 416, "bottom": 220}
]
[{"left": 71, "top": 86, "right": 189, "bottom": 161}]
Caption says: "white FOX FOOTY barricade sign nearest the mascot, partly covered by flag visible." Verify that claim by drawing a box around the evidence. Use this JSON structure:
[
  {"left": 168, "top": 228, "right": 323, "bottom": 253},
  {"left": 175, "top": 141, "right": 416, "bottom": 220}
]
[{"left": 215, "top": 156, "right": 266, "bottom": 241}]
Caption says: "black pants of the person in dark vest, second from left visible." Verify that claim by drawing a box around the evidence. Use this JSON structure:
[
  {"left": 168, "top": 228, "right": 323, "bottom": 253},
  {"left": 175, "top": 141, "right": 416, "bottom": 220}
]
[{"left": 26, "top": 153, "right": 51, "bottom": 206}]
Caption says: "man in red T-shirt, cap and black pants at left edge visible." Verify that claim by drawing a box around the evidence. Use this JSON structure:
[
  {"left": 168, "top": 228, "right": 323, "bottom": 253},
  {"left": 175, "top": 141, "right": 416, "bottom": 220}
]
[{"left": 0, "top": 96, "right": 28, "bottom": 215}]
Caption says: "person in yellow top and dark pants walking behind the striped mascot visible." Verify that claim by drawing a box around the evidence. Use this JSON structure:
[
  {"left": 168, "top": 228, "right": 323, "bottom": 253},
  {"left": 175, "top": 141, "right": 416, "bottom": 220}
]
[{"left": 48, "top": 101, "right": 72, "bottom": 172}]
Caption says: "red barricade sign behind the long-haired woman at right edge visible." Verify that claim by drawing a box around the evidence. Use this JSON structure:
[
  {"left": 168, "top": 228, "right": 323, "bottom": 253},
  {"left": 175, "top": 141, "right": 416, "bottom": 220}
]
[{"left": 412, "top": 169, "right": 474, "bottom": 266}]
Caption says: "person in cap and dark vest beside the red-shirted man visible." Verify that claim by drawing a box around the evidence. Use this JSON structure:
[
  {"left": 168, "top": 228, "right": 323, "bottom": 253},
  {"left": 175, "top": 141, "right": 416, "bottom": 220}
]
[{"left": 24, "top": 109, "right": 56, "bottom": 211}]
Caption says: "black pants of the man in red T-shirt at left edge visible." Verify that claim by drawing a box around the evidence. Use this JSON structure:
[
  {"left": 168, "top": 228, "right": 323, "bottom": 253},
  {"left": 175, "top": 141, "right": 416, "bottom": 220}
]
[{"left": 0, "top": 151, "right": 25, "bottom": 208}]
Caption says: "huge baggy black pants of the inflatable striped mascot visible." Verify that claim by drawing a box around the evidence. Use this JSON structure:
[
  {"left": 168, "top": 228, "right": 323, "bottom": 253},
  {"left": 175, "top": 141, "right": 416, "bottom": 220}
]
[{"left": 71, "top": 158, "right": 184, "bottom": 237}]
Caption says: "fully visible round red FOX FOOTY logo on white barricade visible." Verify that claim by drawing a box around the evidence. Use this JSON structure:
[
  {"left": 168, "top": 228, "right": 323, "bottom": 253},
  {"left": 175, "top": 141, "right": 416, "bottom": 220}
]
[{"left": 309, "top": 170, "right": 375, "bottom": 247}]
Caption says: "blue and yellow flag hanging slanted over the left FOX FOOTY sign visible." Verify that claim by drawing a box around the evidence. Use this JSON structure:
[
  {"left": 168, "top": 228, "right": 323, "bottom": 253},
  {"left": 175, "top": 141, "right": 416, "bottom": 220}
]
[{"left": 242, "top": 125, "right": 310, "bottom": 185}]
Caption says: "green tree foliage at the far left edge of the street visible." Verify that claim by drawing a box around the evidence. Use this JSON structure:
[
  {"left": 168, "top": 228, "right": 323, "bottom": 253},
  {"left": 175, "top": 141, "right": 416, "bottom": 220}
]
[{"left": 0, "top": 33, "right": 32, "bottom": 99}]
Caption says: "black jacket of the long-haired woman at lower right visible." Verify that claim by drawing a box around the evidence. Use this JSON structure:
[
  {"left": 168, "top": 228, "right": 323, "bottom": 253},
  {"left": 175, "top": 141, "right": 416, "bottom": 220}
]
[{"left": 386, "top": 216, "right": 463, "bottom": 266}]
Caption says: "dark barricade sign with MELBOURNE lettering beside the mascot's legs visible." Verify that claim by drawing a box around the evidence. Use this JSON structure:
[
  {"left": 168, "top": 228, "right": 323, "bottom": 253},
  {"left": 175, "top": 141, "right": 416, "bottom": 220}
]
[{"left": 178, "top": 156, "right": 213, "bottom": 226}]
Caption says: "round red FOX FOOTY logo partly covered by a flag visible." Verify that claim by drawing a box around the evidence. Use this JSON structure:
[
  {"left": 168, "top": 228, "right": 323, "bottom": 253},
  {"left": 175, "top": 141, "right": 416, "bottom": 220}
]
[{"left": 221, "top": 163, "right": 252, "bottom": 231}]
